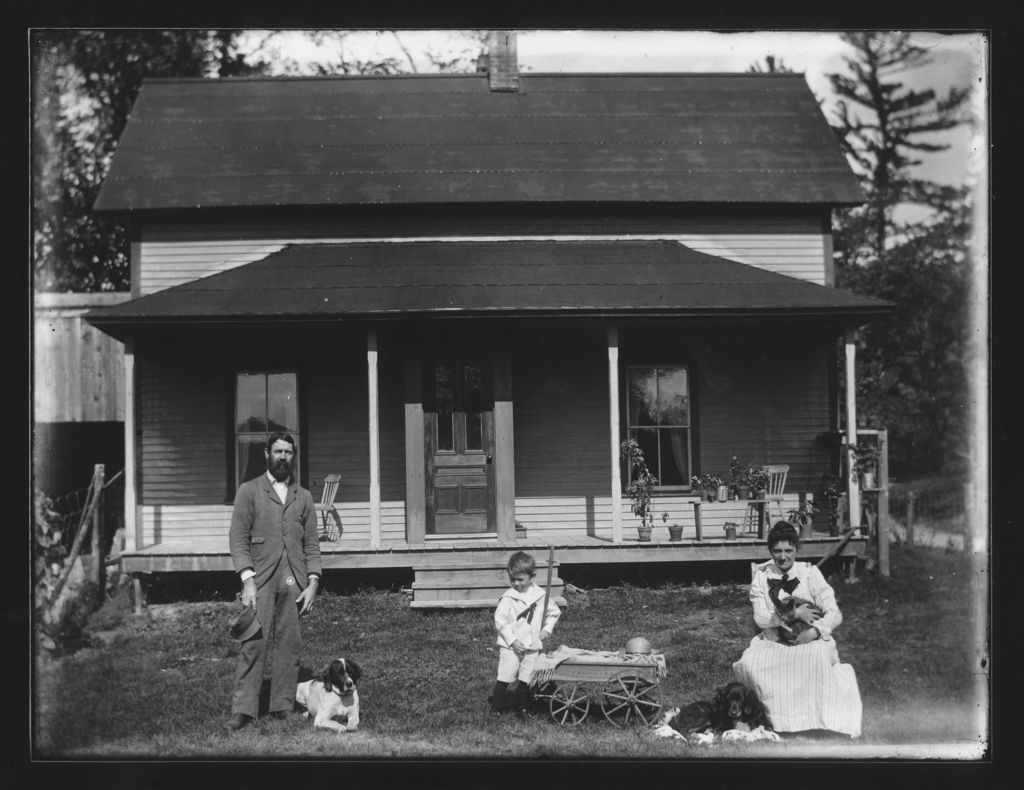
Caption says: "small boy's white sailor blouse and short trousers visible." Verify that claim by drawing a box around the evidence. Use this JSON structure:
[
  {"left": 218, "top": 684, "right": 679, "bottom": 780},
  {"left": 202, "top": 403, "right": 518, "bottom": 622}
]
[{"left": 495, "top": 584, "right": 562, "bottom": 683}]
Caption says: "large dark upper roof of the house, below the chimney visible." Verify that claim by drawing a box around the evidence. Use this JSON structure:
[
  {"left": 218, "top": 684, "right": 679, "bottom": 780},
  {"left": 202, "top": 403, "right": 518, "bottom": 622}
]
[{"left": 94, "top": 74, "right": 864, "bottom": 211}]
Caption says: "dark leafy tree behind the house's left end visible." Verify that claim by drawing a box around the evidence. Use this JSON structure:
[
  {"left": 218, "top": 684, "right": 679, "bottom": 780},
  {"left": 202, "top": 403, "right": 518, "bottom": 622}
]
[{"left": 32, "top": 30, "right": 262, "bottom": 291}]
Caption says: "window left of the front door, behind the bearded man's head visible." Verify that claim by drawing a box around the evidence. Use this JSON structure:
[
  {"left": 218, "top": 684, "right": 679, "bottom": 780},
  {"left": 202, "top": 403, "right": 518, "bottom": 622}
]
[{"left": 234, "top": 371, "right": 302, "bottom": 488}]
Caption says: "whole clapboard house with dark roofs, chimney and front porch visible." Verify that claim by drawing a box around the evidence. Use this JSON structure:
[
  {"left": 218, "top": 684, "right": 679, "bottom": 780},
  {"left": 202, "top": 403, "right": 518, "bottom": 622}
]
[{"left": 88, "top": 41, "right": 888, "bottom": 606}]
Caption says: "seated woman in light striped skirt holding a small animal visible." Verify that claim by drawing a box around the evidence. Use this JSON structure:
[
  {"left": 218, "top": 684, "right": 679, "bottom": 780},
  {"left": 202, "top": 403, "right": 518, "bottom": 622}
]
[{"left": 732, "top": 522, "right": 861, "bottom": 738}]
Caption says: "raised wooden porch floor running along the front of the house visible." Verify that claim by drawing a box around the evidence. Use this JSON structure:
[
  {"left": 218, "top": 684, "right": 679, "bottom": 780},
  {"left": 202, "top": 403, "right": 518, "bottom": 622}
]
[{"left": 109, "top": 534, "right": 867, "bottom": 574}]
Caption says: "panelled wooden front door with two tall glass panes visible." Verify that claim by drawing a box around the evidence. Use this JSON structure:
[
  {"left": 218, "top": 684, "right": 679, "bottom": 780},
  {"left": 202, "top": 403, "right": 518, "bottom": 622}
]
[{"left": 423, "top": 358, "right": 496, "bottom": 535}]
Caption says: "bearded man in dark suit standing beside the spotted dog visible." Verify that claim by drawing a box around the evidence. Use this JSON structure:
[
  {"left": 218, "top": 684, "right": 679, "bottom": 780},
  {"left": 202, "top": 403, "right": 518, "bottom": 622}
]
[{"left": 227, "top": 433, "right": 323, "bottom": 732}]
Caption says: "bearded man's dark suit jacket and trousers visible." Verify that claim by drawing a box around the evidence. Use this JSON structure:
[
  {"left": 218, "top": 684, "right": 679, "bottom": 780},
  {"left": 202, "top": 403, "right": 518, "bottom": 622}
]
[{"left": 228, "top": 473, "right": 322, "bottom": 718}]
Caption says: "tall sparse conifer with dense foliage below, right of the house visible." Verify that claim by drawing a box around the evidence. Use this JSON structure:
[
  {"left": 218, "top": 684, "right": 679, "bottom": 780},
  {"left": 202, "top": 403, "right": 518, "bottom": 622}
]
[{"left": 828, "top": 33, "right": 973, "bottom": 474}]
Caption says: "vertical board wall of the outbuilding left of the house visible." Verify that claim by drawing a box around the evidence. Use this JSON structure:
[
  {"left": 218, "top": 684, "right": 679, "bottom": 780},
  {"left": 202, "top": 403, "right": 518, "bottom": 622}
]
[{"left": 33, "top": 293, "right": 130, "bottom": 422}]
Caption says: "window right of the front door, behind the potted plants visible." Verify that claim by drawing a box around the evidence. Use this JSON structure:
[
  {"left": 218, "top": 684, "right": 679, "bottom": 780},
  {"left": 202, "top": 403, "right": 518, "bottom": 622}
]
[{"left": 626, "top": 365, "right": 692, "bottom": 490}]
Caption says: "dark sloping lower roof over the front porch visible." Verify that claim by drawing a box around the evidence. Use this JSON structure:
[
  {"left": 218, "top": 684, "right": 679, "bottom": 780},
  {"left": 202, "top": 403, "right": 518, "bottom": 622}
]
[{"left": 86, "top": 241, "right": 892, "bottom": 337}]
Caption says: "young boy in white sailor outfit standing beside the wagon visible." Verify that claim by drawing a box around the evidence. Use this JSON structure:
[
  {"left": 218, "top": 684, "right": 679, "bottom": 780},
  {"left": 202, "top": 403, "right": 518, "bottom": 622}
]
[{"left": 489, "top": 551, "right": 562, "bottom": 712}]
